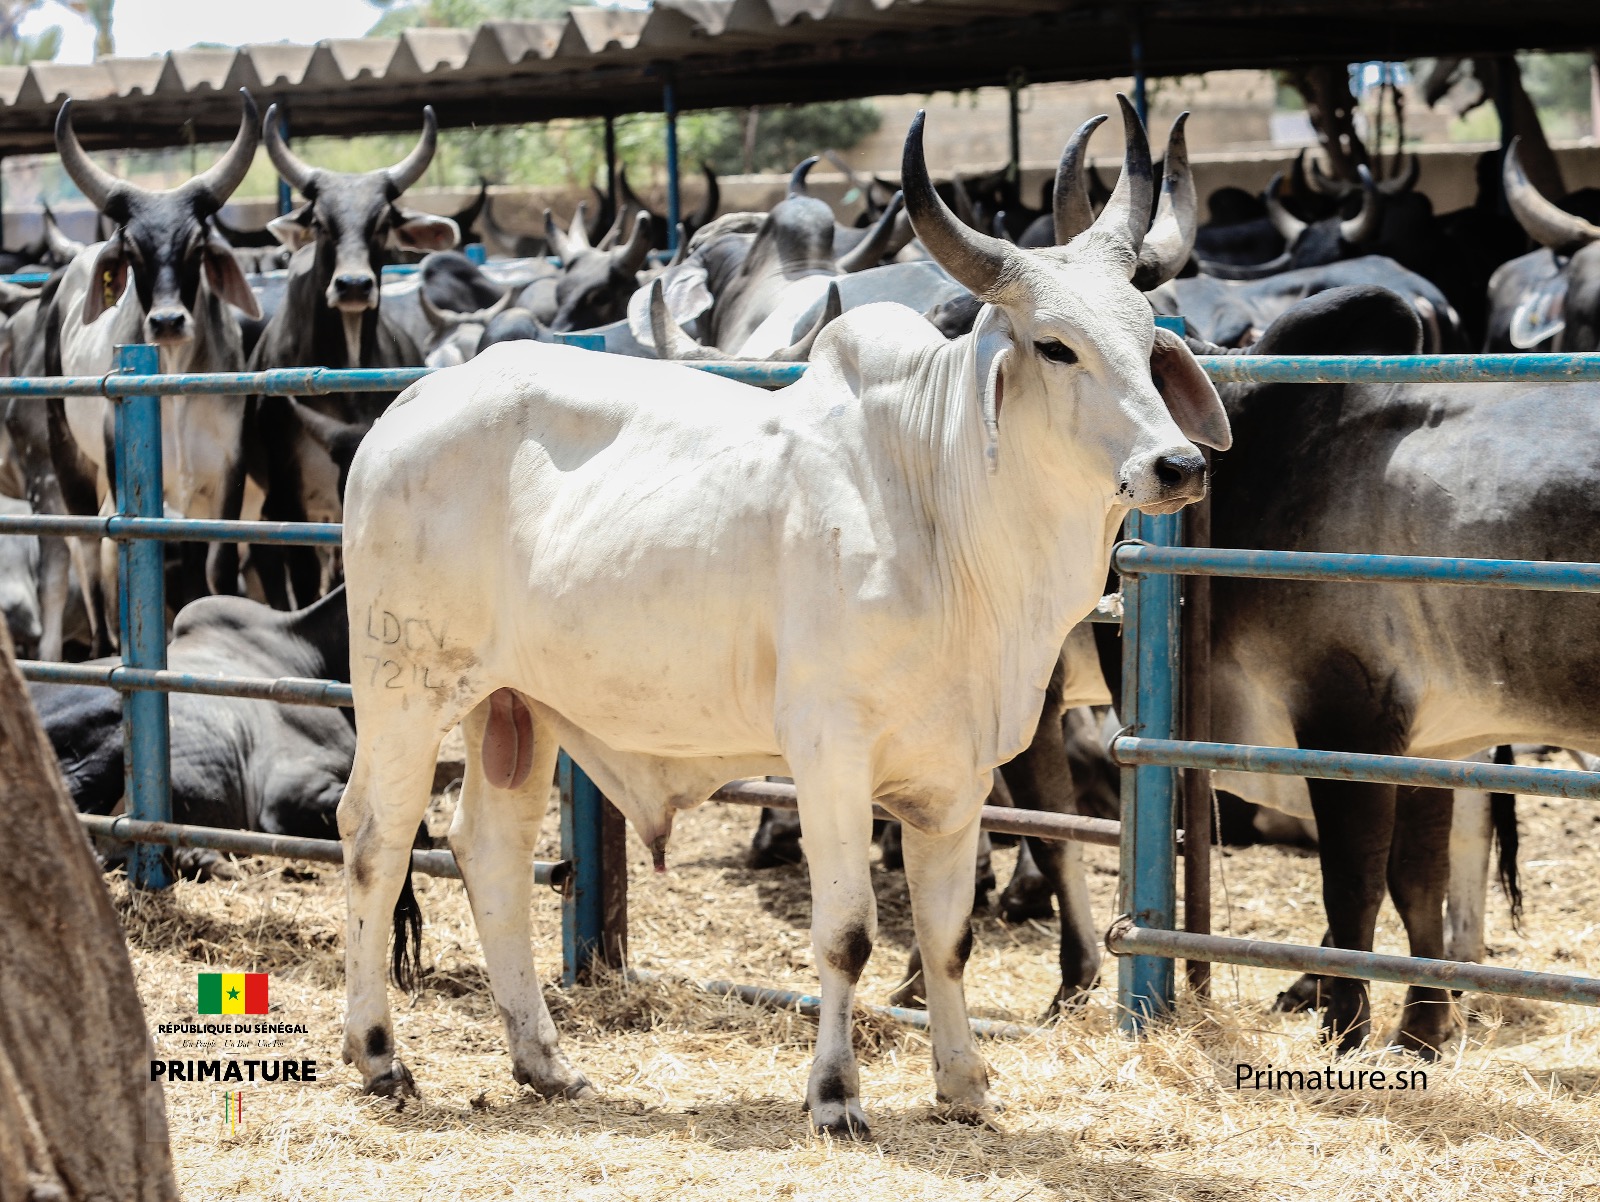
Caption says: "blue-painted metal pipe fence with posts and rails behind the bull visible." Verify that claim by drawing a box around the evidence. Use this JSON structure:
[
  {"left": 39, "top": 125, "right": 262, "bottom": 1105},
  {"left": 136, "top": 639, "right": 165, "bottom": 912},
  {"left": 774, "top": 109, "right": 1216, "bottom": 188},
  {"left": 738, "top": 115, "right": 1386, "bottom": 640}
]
[{"left": 12, "top": 338, "right": 1600, "bottom": 1031}]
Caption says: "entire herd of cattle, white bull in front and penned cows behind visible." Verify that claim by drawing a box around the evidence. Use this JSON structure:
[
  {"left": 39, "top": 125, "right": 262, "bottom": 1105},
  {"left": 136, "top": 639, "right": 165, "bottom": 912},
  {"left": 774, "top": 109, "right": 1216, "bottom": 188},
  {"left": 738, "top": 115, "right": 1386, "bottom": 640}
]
[{"left": 12, "top": 84, "right": 1600, "bottom": 1132}]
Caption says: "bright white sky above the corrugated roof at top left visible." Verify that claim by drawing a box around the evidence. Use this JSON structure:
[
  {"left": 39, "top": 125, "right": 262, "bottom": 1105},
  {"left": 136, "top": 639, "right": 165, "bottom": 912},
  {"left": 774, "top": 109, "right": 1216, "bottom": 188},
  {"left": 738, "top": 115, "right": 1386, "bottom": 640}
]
[{"left": 22, "top": 0, "right": 390, "bottom": 62}]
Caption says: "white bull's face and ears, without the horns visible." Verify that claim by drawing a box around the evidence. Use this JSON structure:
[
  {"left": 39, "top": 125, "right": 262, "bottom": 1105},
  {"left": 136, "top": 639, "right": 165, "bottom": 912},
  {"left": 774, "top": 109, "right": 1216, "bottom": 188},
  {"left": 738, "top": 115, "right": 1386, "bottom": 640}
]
[{"left": 976, "top": 246, "right": 1227, "bottom": 514}]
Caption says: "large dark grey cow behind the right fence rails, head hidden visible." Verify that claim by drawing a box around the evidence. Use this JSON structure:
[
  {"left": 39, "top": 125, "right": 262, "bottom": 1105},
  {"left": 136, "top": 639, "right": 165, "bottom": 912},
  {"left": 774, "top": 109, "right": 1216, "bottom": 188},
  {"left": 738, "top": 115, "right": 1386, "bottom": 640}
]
[{"left": 1211, "top": 286, "right": 1600, "bottom": 1055}]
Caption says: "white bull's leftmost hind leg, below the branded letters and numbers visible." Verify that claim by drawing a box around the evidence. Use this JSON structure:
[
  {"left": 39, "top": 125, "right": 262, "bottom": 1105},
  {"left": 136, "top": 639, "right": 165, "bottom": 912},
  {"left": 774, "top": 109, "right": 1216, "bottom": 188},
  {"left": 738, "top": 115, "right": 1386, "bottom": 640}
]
[{"left": 339, "top": 712, "right": 440, "bottom": 1096}]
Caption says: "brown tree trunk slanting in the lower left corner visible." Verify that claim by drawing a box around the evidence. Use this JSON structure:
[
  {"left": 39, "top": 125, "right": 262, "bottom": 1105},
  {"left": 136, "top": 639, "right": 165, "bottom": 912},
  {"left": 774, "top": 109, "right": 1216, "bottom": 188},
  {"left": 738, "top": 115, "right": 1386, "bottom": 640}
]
[{"left": 0, "top": 634, "right": 178, "bottom": 1202}]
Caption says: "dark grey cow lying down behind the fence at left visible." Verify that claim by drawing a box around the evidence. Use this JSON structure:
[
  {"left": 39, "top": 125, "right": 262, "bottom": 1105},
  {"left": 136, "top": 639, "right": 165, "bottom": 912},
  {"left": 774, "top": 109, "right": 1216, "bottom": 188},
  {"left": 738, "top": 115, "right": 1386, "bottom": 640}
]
[{"left": 29, "top": 587, "right": 355, "bottom": 839}]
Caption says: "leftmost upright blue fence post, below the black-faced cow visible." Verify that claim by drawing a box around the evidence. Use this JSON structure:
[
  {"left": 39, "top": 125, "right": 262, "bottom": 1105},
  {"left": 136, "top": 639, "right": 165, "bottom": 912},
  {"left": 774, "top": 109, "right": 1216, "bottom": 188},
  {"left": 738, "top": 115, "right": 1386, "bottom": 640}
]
[{"left": 112, "top": 344, "right": 173, "bottom": 888}]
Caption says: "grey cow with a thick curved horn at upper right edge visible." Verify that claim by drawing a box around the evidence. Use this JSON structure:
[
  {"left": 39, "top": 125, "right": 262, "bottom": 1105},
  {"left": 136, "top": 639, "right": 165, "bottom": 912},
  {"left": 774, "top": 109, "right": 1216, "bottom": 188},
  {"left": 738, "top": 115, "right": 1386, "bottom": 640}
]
[{"left": 1483, "top": 139, "right": 1600, "bottom": 351}]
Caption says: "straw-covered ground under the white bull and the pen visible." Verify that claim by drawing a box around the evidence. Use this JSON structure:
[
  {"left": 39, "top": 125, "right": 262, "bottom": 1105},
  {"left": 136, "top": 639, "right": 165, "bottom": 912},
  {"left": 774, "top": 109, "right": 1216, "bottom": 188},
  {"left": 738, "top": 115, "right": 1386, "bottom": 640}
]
[{"left": 112, "top": 765, "right": 1600, "bottom": 1202}]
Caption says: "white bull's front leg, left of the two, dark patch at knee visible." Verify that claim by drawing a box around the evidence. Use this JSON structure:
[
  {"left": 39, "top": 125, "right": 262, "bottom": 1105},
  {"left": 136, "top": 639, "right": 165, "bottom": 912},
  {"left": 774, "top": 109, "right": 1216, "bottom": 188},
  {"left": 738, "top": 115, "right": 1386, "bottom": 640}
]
[{"left": 790, "top": 755, "right": 883, "bottom": 1140}]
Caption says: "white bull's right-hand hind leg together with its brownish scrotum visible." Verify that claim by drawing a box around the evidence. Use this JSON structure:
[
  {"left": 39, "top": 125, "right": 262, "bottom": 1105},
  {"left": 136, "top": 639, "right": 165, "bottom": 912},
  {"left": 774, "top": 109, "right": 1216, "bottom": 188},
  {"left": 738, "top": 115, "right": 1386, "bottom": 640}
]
[{"left": 450, "top": 688, "right": 594, "bottom": 1098}]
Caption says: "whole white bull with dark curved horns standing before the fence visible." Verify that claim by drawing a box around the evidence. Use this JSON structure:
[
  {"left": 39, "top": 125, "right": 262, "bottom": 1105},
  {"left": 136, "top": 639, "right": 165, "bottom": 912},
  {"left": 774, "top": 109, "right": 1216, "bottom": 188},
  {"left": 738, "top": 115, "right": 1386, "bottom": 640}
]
[{"left": 339, "top": 101, "right": 1229, "bottom": 1135}]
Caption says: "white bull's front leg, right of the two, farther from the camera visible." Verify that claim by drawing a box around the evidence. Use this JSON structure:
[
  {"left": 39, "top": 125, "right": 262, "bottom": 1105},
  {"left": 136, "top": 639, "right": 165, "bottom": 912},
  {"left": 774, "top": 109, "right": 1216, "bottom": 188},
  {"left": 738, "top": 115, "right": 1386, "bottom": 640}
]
[{"left": 904, "top": 805, "right": 992, "bottom": 1119}]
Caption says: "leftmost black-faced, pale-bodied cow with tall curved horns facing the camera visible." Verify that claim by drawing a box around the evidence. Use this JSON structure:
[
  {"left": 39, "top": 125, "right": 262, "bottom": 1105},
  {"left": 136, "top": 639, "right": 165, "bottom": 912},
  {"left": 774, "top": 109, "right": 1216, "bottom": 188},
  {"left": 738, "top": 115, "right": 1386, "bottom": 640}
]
[{"left": 40, "top": 90, "right": 261, "bottom": 653}]
